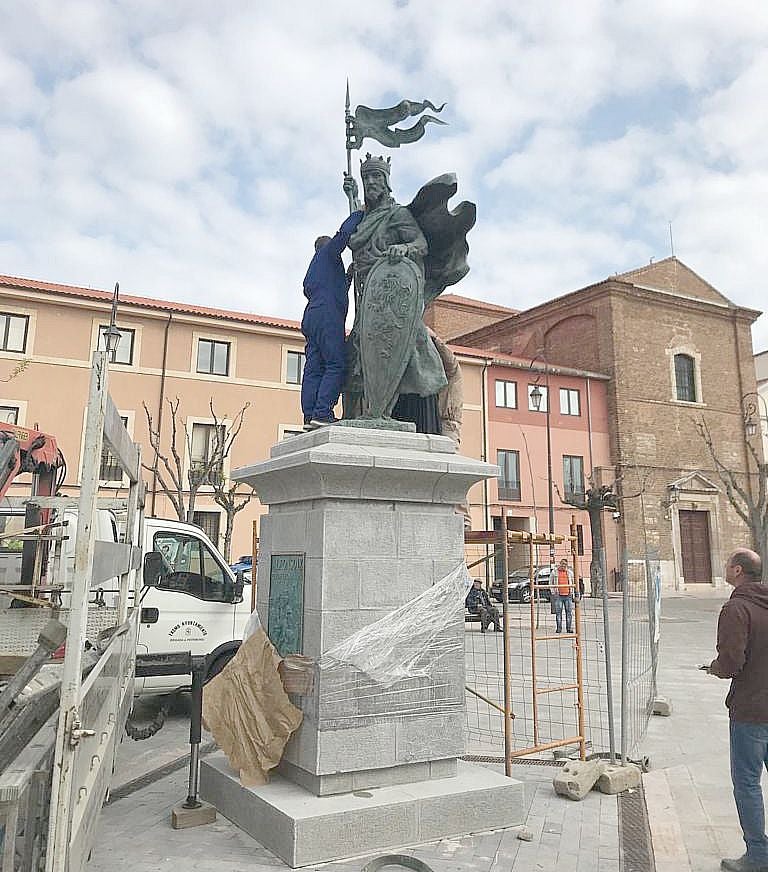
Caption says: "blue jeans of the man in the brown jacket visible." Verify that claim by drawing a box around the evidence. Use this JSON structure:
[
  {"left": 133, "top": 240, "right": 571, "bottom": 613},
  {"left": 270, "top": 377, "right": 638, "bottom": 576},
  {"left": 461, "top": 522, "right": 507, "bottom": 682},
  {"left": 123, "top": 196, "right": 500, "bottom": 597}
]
[{"left": 730, "top": 721, "right": 768, "bottom": 866}]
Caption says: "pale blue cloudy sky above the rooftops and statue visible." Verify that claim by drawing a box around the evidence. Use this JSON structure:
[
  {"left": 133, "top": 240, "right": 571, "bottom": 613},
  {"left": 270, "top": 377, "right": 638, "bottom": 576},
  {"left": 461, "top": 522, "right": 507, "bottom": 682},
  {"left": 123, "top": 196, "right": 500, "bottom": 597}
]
[{"left": 0, "top": 0, "right": 768, "bottom": 350}]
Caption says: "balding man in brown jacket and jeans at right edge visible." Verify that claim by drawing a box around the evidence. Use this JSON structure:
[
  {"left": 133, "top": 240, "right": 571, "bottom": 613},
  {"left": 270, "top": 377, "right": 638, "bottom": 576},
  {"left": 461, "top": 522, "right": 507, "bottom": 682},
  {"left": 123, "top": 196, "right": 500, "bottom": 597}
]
[{"left": 707, "top": 548, "right": 768, "bottom": 872}]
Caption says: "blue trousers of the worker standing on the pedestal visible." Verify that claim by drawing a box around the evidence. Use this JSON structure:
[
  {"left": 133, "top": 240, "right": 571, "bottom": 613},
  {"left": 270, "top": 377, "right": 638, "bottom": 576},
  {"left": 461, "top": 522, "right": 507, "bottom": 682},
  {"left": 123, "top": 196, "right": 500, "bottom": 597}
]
[{"left": 301, "top": 309, "right": 347, "bottom": 420}]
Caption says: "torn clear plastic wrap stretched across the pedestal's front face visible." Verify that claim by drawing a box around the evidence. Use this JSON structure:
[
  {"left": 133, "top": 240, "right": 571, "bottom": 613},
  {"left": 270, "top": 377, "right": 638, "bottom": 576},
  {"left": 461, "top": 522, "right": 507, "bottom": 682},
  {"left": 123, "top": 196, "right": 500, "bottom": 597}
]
[{"left": 317, "top": 564, "right": 471, "bottom": 729}]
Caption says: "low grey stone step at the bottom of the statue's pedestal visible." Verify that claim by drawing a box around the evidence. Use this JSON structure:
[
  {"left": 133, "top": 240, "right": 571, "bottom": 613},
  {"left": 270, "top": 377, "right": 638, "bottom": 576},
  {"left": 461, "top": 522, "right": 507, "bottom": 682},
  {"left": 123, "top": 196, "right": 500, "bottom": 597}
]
[{"left": 200, "top": 752, "right": 526, "bottom": 869}]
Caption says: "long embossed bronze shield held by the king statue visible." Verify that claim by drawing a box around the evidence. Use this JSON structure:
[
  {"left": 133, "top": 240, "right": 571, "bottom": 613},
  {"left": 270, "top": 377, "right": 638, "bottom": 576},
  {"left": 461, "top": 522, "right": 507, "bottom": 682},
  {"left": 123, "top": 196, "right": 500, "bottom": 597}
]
[{"left": 360, "top": 257, "right": 424, "bottom": 418}]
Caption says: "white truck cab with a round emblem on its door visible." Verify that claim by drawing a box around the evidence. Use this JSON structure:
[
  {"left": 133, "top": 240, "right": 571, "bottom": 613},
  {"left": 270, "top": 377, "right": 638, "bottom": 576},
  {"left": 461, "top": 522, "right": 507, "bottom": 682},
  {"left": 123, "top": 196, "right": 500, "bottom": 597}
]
[{"left": 135, "top": 518, "right": 251, "bottom": 695}]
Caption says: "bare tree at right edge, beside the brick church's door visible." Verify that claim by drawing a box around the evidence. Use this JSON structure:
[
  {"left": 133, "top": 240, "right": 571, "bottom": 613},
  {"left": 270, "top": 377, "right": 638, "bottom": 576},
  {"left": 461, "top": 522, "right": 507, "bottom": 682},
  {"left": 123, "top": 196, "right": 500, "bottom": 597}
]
[{"left": 695, "top": 416, "right": 768, "bottom": 583}]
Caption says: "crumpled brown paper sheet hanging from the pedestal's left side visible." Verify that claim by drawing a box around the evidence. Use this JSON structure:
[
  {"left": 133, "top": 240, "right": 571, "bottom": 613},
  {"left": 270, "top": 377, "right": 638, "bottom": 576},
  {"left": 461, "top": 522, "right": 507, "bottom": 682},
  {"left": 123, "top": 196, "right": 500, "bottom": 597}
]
[{"left": 203, "top": 628, "right": 302, "bottom": 787}]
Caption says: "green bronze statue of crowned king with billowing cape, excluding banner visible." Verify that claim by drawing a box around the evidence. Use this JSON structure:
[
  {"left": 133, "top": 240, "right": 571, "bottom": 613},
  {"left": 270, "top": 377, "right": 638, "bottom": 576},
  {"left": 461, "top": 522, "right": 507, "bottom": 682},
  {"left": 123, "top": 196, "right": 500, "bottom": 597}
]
[{"left": 344, "top": 154, "right": 476, "bottom": 433}]
